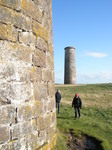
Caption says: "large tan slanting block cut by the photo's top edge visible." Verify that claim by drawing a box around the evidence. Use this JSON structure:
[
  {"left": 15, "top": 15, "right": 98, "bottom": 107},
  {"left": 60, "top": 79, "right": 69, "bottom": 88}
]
[{"left": 21, "top": 0, "right": 42, "bottom": 23}]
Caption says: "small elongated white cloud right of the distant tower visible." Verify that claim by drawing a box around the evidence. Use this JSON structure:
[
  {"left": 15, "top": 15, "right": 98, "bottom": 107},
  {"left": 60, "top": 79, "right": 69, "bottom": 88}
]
[{"left": 85, "top": 52, "right": 108, "bottom": 58}]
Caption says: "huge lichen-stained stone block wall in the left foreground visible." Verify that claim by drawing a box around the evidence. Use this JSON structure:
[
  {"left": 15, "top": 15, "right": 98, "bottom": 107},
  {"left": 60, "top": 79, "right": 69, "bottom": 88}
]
[{"left": 0, "top": 0, "right": 56, "bottom": 150}]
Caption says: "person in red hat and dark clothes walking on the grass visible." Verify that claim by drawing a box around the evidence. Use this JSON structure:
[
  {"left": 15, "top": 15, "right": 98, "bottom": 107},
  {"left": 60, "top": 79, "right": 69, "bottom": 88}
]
[{"left": 72, "top": 94, "right": 82, "bottom": 119}]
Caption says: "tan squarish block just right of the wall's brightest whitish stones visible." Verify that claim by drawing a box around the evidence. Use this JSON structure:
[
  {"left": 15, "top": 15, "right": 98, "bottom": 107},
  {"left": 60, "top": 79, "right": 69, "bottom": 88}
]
[{"left": 34, "top": 82, "right": 47, "bottom": 100}]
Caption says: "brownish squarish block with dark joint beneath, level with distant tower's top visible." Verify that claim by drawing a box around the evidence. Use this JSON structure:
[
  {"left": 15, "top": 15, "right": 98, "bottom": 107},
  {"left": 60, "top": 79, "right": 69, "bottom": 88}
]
[{"left": 32, "top": 49, "right": 46, "bottom": 67}]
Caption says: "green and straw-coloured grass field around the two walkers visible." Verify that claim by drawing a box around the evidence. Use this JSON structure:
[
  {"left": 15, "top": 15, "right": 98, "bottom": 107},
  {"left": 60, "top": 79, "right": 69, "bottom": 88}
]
[{"left": 53, "top": 84, "right": 112, "bottom": 150}]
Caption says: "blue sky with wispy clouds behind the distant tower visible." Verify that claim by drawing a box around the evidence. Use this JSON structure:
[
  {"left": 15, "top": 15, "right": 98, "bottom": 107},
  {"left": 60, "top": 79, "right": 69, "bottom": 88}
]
[{"left": 52, "top": 0, "right": 112, "bottom": 84}]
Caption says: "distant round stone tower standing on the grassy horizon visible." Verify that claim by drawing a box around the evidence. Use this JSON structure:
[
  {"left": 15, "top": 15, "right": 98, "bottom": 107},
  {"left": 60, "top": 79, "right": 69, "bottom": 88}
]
[{"left": 64, "top": 47, "right": 76, "bottom": 84}]
